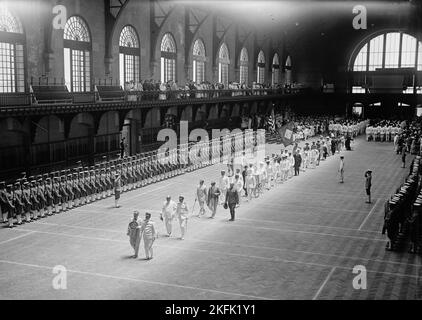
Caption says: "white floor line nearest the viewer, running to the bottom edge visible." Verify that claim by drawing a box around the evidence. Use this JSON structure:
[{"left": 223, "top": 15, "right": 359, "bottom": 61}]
[{"left": 0, "top": 260, "right": 273, "bottom": 300}]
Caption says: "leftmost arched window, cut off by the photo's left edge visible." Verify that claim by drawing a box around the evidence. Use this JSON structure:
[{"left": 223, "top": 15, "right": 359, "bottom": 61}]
[{"left": 0, "top": 4, "right": 25, "bottom": 93}]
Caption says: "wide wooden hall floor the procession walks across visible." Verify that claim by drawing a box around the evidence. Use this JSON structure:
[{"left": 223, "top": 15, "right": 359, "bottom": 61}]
[{"left": 0, "top": 139, "right": 422, "bottom": 299}]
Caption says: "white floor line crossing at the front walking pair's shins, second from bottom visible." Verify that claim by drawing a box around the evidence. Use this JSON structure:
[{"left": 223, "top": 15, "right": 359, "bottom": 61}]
[{"left": 6, "top": 230, "right": 415, "bottom": 278}]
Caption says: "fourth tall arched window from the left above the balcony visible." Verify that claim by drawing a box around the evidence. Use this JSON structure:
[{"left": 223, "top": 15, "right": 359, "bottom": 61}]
[{"left": 161, "top": 33, "right": 177, "bottom": 82}]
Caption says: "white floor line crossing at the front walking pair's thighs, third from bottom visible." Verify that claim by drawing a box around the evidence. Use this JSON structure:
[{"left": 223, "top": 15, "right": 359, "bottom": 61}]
[{"left": 29, "top": 222, "right": 422, "bottom": 267}]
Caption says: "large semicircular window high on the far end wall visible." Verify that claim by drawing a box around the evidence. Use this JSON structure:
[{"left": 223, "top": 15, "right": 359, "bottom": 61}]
[{"left": 352, "top": 32, "right": 422, "bottom": 71}]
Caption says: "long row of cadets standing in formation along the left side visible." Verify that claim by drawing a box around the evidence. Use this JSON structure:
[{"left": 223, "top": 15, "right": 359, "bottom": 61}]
[{"left": 0, "top": 150, "right": 205, "bottom": 228}]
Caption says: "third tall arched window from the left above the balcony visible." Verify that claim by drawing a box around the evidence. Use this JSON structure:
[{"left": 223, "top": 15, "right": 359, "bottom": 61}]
[{"left": 119, "top": 26, "right": 139, "bottom": 88}]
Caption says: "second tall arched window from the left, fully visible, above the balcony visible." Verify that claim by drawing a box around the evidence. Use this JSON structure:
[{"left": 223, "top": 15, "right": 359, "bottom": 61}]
[{"left": 64, "top": 16, "right": 91, "bottom": 92}]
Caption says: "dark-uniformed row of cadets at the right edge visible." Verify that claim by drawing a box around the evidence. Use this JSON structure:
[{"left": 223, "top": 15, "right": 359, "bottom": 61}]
[{"left": 382, "top": 156, "right": 422, "bottom": 253}]
